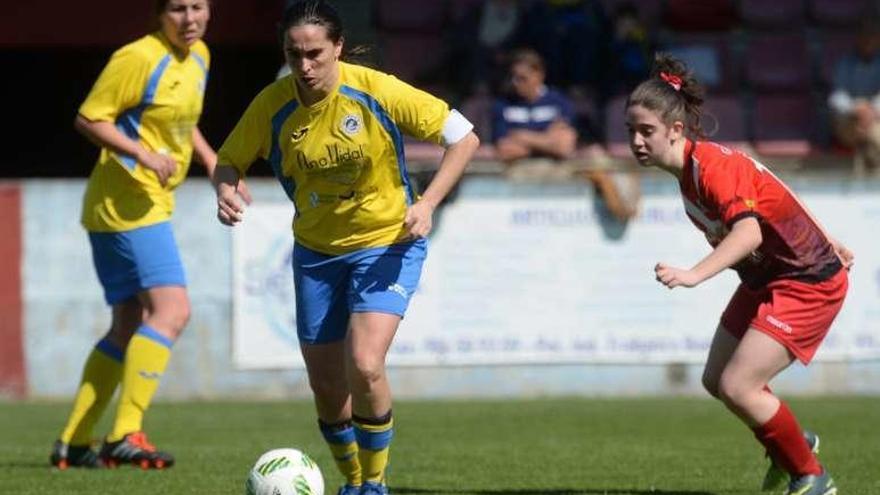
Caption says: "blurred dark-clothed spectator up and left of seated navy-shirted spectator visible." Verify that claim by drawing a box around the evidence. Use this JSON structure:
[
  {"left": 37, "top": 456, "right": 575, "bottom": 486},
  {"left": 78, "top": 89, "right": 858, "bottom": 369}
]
[{"left": 438, "top": 0, "right": 523, "bottom": 98}]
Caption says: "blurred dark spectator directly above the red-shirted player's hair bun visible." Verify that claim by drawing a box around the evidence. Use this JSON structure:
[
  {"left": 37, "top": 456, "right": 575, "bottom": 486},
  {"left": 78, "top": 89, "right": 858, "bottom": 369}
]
[{"left": 609, "top": 2, "right": 653, "bottom": 93}]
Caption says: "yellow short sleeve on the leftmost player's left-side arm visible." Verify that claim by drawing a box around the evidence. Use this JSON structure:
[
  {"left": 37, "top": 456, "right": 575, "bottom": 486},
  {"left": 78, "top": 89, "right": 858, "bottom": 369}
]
[{"left": 79, "top": 47, "right": 150, "bottom": 122}]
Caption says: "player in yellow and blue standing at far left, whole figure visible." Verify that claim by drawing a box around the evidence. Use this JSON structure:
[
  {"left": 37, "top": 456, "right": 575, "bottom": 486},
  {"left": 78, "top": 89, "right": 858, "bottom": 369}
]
[{"left": 50, "top": 0, "right": 246, "bottom": 468}]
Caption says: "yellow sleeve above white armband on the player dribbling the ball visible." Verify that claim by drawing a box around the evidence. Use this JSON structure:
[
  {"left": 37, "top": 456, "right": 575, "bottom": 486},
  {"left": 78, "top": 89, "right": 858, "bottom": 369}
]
[{"left": 379, "top": 74, "right": 450, "bottom": 144}]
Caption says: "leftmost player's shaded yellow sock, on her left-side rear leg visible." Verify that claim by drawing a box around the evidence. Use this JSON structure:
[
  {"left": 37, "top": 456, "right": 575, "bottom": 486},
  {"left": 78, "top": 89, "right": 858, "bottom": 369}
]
[{"left": 61, "top": 338, "right": 123, "bottom": 446}]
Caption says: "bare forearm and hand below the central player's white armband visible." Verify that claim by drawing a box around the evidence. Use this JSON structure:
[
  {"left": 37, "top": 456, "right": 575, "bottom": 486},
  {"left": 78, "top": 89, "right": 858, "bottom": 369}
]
[{"left": 404, "top": 132, "right": 480, "bottom": 237}]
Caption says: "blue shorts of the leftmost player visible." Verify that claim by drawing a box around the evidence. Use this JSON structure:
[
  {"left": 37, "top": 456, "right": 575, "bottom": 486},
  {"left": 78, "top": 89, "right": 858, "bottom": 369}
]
[{"left": 89, "top": 222, "right": 186, "bottom": 305}]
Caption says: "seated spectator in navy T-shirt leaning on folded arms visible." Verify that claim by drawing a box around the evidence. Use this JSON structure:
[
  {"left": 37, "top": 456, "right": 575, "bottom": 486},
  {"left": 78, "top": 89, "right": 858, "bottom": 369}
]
[{"left": 492, "top": 49, "right": 577, "bottom": 163}]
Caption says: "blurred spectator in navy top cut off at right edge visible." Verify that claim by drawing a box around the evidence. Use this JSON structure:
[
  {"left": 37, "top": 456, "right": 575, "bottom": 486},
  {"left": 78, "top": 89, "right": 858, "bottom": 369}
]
[{"left": 828, "top": 18, "right": 880, "bottom": 176}]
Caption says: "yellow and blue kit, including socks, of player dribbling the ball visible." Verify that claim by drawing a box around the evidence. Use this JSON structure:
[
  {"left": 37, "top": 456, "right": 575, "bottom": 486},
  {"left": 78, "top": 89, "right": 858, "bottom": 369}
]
[{"left": 218, "top": 62, "right": 460, "bottom": 486}]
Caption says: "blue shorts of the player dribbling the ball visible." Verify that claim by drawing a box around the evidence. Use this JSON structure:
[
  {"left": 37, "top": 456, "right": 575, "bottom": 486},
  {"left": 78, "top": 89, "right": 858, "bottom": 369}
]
[{"left": 293, "top": 239, "right": 428, "bottom": 344}]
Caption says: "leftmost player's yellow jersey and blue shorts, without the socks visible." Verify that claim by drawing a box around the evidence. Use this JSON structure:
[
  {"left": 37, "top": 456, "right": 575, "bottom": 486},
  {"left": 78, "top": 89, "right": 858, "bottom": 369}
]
[{"left": 79, "top": 32, "right": 210, "bottom": 304}]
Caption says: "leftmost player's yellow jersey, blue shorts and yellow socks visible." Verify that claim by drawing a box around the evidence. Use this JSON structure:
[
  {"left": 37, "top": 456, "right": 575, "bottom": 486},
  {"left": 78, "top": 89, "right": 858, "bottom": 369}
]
[{"left": 60, "top": 32, "right": 210, "bottom": 454}]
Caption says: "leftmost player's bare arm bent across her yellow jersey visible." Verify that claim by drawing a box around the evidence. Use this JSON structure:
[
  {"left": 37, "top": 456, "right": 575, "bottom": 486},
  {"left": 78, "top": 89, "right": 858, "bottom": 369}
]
[{"left": 73, "top": 114, "right": 177, "bottom": 186}]
